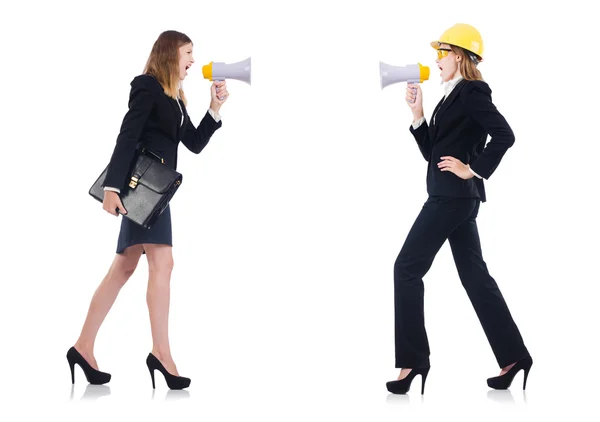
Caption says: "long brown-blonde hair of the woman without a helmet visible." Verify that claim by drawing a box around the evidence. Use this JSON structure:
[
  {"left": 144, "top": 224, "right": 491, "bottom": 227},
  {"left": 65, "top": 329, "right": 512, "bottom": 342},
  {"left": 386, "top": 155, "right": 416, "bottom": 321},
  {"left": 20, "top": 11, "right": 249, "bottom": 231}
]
[{"left": 144, "top": 31, "right": 192, "bottom": 106}]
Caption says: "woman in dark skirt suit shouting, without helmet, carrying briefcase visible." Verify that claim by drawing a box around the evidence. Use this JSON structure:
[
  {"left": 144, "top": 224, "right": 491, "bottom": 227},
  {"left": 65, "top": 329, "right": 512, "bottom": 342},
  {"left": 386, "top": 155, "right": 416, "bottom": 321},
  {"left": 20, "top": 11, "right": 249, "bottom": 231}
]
[{"left": 67, "top": 31, "right": 229, "bottom": 389}]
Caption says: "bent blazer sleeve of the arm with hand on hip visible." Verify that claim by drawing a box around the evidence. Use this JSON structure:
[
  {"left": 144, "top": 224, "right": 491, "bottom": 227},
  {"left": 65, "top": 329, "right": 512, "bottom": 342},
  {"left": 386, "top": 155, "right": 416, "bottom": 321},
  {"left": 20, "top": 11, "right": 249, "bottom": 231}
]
[{"left": 461, "top": 81, "right": 515, "bottom": 179}]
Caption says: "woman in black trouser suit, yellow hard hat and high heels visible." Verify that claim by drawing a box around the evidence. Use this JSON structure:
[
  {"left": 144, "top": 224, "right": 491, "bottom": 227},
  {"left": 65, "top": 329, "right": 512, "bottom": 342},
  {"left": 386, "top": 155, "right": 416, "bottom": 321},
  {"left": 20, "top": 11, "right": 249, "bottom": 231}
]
[{"left": 387, "top": 24, "right": 532, "bottom": 394}]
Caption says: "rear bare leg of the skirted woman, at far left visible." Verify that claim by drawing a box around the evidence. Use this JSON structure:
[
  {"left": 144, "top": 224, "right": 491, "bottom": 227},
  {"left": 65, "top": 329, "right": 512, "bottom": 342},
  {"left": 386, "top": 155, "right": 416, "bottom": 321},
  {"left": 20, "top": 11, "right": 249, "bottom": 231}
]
[{"left": 74, "top": 245, "right": 143, "bottom": 369}]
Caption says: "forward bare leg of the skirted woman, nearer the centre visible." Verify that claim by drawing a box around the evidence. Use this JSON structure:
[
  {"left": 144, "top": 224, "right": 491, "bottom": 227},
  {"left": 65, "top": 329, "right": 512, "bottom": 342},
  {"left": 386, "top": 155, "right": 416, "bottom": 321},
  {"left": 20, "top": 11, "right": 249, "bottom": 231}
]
[{"left": 144, "top": 244, "right": 179, "bottom": 376}]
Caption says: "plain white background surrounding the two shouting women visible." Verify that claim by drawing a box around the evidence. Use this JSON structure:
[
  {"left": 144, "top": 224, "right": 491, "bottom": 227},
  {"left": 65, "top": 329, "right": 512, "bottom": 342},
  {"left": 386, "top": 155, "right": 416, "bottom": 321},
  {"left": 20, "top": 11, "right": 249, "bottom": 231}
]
[{"left": 0, "top": 0, "right": 600, "bottom": 421}]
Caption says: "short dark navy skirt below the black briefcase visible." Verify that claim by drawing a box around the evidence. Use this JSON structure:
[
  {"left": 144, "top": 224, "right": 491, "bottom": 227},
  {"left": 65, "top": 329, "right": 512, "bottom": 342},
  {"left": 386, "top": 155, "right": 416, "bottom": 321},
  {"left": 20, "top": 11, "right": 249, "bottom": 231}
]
[{"left": 117, "top": 205, "right": 173, "bottom": 254}]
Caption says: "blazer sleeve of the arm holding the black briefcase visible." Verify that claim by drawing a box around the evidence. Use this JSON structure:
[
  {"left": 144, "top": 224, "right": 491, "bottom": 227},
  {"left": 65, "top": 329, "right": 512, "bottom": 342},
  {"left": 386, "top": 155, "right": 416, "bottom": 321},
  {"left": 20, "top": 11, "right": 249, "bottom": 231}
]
[{"left": 103, "top": 75, "right": 160, "bottom": 189}]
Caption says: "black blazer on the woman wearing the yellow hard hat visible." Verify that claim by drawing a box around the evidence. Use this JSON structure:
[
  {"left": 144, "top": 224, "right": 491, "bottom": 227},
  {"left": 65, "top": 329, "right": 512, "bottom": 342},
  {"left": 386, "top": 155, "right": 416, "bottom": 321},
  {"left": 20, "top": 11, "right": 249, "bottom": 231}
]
[{"left": 410, "top": 79, "right": 515, "bottom": 202}]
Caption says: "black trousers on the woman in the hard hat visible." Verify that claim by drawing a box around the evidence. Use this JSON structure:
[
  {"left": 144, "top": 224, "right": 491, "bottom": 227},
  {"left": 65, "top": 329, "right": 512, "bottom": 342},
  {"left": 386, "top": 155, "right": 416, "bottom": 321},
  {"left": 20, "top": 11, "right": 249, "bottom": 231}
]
[{"left": 394, "top": 197, "right": 529, "bottom": 368}]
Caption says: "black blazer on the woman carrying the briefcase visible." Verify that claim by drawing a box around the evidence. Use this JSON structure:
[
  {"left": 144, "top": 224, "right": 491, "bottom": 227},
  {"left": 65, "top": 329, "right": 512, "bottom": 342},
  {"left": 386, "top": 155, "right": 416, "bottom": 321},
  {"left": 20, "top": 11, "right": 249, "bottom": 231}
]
[{"left": 103, "top": 74, "right": 222, "bottom": 189}]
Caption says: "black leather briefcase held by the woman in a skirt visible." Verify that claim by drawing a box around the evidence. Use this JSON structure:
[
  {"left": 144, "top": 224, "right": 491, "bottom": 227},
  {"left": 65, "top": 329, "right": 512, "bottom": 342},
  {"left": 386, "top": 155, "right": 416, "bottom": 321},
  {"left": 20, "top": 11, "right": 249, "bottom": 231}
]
[{"left": 89, "top": 149, "right": 183, "bottom": 229}]
